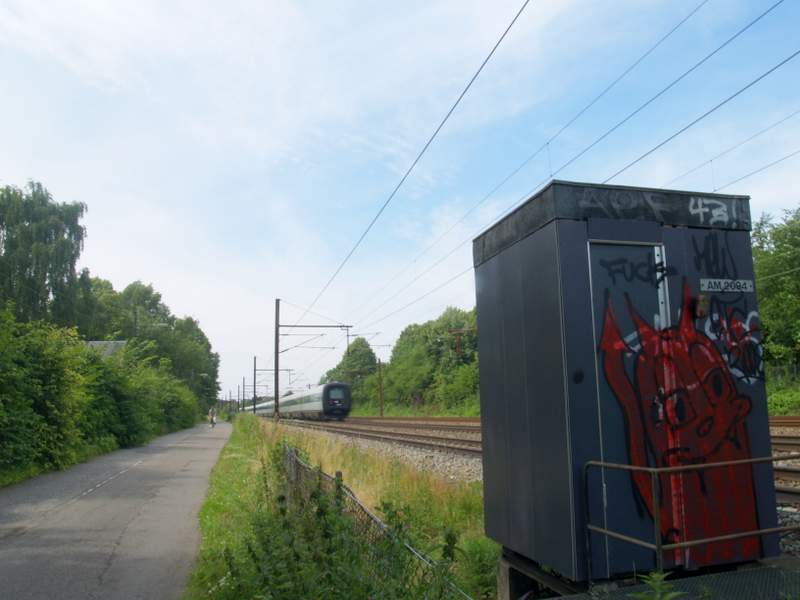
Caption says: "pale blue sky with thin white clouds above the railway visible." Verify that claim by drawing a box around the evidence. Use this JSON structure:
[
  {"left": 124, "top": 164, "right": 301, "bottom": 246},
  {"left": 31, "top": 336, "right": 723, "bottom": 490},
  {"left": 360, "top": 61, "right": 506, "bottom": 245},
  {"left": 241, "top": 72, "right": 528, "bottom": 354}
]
[{"left": 0, "top": 0, "right": 800, "bottom": 397}]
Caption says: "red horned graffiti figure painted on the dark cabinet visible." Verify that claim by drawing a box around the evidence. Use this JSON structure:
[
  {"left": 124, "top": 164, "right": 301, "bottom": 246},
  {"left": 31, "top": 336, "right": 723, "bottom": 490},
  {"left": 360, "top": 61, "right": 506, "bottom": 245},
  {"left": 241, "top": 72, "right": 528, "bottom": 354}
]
[{"left": 600, "top": 285, "right": 761, "bottom": 567}]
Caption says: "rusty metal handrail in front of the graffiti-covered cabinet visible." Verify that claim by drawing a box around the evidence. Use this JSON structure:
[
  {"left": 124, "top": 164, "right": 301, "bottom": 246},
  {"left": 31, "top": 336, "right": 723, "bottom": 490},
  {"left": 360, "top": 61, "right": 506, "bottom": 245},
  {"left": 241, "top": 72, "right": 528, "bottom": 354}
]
[{"left": 583, "top": 453, "right": 800, "bottom": 583}]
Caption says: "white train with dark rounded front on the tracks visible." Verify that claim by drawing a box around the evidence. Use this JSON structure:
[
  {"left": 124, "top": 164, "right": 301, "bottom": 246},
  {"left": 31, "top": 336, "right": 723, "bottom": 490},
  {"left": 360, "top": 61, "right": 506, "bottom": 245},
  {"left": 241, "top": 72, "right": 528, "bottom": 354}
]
[{"left": 255, "top": 381, "right": 352, "bottom": 421}]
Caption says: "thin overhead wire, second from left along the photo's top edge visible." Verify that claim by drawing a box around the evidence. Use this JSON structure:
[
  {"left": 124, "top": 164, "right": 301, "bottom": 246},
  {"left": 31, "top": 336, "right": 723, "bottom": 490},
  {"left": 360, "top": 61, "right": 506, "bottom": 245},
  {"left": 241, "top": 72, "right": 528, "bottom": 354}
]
[{"left": 346, "top": 0, "right": 709, "bottom": 324}]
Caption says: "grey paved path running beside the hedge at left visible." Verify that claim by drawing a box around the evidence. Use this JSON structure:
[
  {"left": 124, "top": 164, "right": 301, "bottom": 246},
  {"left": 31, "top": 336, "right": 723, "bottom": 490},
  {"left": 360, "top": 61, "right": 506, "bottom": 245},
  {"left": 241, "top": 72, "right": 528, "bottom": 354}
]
[{"left": 0, "top": 423, "right": 231, "bottom": 600}]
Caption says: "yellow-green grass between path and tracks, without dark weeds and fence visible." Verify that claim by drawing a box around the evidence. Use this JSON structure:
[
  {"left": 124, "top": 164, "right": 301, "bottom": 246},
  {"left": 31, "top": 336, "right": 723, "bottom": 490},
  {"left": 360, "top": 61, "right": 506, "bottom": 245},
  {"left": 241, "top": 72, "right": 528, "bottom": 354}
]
[{"left": 184, "top": 415, "right": 499, "bottom": 600}]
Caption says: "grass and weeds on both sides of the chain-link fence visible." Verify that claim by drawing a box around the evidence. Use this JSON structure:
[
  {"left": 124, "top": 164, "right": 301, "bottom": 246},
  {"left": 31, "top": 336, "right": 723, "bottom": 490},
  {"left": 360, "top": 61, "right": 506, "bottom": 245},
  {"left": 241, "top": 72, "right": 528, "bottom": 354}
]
[{"left": 189, "top": 415, "right": 499, "bottom": 600}]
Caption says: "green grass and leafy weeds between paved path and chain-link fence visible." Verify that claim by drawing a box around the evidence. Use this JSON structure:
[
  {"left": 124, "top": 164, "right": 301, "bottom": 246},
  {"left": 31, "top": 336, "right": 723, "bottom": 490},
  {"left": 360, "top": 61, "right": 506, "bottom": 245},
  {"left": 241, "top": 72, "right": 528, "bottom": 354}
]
[{"left": 184, "top": 415, "right": 484, "bottom": 600}]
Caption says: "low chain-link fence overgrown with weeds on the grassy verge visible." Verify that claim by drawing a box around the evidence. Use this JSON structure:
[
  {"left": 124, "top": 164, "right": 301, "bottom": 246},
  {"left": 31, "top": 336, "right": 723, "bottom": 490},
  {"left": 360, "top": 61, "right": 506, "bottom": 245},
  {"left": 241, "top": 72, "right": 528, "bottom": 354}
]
[{"left": 284, "top": 445, "right": 470, "bottom": 600}]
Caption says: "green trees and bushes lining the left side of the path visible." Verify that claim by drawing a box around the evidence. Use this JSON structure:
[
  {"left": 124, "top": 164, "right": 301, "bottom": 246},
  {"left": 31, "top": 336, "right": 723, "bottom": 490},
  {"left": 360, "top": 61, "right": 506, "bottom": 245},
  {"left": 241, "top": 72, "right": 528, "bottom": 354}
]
[{"left": 0, "top": 183, "right": 219, "bottom": 486}]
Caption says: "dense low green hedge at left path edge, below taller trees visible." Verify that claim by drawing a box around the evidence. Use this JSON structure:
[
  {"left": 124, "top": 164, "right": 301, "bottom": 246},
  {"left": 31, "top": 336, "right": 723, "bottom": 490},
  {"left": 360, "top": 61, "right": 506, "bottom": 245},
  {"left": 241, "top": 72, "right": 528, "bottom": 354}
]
[{"left": 0, "top": 308, "right": 200, "bottom": 485}]
